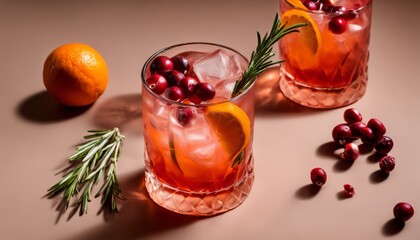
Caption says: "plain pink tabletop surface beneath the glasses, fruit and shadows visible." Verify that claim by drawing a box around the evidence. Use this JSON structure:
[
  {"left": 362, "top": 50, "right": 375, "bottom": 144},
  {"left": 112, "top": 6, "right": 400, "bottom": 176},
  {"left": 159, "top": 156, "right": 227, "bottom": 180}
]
[{"left": 0, "top": 0, "right": 420, "bottom": 240}]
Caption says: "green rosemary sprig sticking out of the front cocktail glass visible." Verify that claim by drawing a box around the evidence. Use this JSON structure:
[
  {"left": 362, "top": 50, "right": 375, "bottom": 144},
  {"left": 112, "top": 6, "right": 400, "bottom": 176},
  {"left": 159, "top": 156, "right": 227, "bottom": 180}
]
[{"left": 231, "top": 14, "right": 306, "bottom": 98}]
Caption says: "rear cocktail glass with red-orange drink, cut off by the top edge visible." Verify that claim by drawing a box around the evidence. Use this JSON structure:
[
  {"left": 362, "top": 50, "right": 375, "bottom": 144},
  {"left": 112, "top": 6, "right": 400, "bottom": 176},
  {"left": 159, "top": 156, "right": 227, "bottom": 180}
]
[{"left": 279, "top": 0, "right": 372, "bottom": 108}]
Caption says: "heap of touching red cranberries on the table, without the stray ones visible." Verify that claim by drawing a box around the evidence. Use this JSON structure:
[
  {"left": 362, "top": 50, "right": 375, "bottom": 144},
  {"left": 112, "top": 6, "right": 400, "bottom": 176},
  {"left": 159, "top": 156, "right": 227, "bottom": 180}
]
[{"left": 332, "top": 108, "right": 395, "bottom": 173}]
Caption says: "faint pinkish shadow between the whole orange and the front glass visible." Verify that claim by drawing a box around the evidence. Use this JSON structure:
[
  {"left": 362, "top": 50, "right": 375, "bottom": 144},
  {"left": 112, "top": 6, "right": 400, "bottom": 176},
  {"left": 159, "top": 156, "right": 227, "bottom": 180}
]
[{"left": 93, "top": 93, "right": 143, "bottom": 134}]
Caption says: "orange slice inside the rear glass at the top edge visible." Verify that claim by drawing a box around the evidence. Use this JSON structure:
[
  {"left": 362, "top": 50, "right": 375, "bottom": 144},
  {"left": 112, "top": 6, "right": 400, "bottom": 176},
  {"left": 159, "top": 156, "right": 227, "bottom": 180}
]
[{"left": 282, "top": 9, "right": 322, "bottom": 68}]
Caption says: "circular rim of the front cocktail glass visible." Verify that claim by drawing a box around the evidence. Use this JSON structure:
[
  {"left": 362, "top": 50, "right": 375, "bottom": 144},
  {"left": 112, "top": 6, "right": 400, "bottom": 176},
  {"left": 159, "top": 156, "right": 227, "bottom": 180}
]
[{"left": 141, "top": 42, "right": 256, "bottom": 107}]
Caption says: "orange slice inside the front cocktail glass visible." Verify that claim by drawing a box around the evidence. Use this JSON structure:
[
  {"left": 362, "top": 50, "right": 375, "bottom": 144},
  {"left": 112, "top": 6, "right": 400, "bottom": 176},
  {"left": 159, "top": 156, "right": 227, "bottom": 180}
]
[{"left": 204, "top": 102, "right": 251, "bottom": 161}]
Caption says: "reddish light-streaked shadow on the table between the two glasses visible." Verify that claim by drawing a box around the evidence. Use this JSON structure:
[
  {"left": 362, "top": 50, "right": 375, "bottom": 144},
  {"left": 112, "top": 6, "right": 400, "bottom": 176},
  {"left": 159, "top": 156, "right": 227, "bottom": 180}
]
[{"left": 255, "top": 66, "right": 321, "bottom": 116}]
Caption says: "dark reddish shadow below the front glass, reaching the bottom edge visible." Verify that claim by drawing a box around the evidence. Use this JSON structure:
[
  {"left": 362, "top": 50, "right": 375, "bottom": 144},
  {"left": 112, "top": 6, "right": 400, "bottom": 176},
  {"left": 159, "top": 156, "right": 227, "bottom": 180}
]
[{"left": 64, "top": 170, "right": 200, "bottom": 240}]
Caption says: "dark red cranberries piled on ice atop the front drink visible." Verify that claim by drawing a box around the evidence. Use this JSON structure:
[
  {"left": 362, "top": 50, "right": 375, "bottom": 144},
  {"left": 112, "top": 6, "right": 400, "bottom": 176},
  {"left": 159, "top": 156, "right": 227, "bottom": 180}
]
[{"left": 146, "top": 55, "right": 216, "bottom": 104}]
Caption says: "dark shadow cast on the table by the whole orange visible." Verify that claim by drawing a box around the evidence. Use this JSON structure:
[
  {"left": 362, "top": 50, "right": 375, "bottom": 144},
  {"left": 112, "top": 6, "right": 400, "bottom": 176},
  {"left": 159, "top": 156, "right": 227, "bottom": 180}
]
[{"left": 16, "top": 91, "right": 91, "bottom": 123}]
